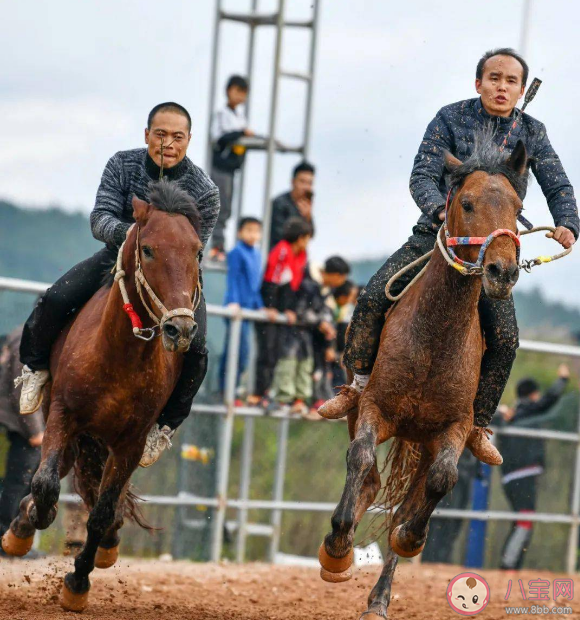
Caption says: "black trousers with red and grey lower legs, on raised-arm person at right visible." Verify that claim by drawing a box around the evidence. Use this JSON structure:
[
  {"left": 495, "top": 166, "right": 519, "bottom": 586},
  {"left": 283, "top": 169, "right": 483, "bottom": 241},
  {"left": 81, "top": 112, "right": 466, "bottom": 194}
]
[{"left": 501, "top": 476, "right": 537, "bottom": 570}]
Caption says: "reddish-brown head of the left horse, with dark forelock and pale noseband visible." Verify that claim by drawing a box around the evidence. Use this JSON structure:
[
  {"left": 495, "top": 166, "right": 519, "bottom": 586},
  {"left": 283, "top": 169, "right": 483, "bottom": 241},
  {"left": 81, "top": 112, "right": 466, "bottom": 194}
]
[{"left": 127, "top": 181, "right": 202, "bottom": 353}]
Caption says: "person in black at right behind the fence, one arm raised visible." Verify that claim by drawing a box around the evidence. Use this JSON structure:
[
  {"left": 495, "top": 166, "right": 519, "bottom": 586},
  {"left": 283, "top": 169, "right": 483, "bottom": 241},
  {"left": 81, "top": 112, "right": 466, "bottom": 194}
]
[{"left": 498, "top": 364, "right": 570, "bottom": 570}]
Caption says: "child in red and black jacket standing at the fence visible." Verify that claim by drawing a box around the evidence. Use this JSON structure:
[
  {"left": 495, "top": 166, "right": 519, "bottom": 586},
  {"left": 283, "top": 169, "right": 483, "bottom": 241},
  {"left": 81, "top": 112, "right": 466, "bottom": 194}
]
[{"left": 256, "top": 218, "right": 312, "bottom": 412}]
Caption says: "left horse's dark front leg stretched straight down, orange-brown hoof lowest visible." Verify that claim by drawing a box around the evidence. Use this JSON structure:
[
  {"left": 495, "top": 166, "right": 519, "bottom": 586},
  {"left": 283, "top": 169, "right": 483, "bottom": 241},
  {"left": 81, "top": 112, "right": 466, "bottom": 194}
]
[{"left": 60, "top": 448, "right": 141, "bottom": 611}]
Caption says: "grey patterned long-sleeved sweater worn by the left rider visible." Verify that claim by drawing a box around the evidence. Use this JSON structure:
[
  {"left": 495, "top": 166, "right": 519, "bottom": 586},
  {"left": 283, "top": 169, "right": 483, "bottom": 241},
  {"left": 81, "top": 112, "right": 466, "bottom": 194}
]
[{"left": 90, "top": 148, "right": 220, "bottom": 247}]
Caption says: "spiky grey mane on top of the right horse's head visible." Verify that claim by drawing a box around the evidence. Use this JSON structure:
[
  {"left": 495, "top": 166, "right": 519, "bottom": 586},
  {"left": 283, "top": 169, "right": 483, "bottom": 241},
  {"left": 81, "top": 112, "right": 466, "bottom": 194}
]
[{"left": 449, "top": 123, "right": 529, "bottom": 198}]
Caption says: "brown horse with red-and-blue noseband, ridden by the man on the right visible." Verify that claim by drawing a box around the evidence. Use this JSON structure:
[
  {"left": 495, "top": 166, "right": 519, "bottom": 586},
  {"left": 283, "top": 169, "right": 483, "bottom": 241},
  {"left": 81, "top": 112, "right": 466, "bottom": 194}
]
[{"left": 319, "top": 137, "right": 527, "bottom": 620}]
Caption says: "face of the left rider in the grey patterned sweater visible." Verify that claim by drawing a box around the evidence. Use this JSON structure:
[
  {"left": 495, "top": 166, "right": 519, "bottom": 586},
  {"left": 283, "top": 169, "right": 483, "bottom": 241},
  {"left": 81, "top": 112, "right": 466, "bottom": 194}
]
[{"left": 145, "top": 110, "right": 191, "bottom": 168}]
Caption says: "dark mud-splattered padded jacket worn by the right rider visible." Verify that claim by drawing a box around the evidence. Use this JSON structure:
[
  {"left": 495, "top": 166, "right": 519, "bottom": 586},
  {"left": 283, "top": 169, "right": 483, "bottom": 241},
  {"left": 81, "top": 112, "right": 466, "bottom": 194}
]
[{"left": 409, "top": 98, "right": 580, "bottom": 238}]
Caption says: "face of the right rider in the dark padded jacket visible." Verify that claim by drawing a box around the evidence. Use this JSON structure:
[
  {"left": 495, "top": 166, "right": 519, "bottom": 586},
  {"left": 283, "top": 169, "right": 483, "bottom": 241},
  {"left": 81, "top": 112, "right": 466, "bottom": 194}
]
[{"left": 475, "top": 55, "right": 525, "bottom": 116}]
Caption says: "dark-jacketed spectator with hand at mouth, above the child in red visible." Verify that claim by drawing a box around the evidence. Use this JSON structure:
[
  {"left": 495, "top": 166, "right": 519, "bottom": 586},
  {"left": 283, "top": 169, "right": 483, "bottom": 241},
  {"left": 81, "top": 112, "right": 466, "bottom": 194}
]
[{"left": 270, "top": 161, "right": 315, "bottom": 249}]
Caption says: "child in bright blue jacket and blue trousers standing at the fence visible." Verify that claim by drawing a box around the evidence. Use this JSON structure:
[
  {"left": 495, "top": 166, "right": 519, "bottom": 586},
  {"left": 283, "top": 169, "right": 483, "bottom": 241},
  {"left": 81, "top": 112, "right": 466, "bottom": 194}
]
[{"left": 219, "top": 217, "right": 277, "bottom": 393}]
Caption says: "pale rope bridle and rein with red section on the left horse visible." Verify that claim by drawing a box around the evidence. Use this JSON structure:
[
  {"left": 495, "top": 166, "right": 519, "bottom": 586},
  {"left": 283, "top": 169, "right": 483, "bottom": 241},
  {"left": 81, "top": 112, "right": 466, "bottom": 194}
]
[{"left": 115, "top": 227, "right": 201, "bottom": 342}]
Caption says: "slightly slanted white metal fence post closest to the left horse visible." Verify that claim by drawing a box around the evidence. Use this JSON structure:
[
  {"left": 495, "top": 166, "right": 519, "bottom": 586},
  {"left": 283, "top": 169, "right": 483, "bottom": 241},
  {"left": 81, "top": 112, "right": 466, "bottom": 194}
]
[{"left": 211, "top": 315, "right": 242, "bottom": 562}]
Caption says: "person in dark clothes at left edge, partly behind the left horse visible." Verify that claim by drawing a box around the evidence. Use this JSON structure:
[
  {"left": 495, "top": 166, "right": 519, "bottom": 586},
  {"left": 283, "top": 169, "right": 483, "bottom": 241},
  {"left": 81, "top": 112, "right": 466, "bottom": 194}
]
[{"left": 0, "top": 328, "right": 44, "bottom": 559}]
